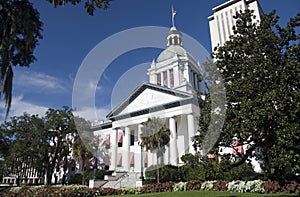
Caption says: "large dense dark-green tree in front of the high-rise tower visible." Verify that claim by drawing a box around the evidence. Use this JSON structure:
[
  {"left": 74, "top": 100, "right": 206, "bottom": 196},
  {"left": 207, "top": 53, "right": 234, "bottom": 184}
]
[{"left": 213, "top": 10, "right": 300, "bottom": 179}]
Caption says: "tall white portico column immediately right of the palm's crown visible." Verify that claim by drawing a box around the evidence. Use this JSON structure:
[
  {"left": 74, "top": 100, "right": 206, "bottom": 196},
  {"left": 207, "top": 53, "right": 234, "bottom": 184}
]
[{"left": 169, "top": 118, "right": 177, "bottom": 165}]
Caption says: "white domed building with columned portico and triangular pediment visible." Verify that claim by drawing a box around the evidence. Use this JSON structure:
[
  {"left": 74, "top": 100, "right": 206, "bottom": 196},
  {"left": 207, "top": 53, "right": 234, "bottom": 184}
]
[{"left": 92, "top": 23, "right": 202, "bottom": 175}]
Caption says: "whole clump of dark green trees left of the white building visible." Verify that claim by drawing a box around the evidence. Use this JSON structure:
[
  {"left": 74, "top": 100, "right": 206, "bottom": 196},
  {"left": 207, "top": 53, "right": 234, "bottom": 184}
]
[{"left": 0, "top": 107, "right": 91, "bottom": 184}]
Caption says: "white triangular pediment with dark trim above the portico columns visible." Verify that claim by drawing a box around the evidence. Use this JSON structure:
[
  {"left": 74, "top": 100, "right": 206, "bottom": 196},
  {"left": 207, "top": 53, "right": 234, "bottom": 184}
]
[{"left": 107, "top": 83, "right": 192, "bottom": 118}]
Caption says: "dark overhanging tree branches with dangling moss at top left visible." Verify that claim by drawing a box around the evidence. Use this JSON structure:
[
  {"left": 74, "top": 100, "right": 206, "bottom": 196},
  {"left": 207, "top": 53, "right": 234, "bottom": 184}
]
[{"left": 0, "top": 0, "right": 111, "bottom": 117}]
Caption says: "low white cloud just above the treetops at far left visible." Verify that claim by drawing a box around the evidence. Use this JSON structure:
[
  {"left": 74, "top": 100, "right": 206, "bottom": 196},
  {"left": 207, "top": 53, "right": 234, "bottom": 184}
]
[{"left": 0, "top": 96, "right": 48, "bottom": 122}]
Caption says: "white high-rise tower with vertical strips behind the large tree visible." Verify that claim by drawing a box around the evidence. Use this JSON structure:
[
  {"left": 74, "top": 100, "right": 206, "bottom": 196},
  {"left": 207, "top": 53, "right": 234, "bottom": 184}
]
[{"left": 208, "top": 0, "right": 263, "bottom": 50}]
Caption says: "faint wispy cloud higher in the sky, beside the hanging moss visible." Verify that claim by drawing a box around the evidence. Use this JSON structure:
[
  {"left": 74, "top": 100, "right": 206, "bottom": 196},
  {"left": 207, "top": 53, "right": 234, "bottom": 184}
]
[{"left": 14, "top": 71, "right": 65, "bottom": 92}]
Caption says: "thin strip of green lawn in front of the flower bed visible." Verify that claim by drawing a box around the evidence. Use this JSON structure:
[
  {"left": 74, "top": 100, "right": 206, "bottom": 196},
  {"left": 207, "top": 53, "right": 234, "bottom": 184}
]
[{"left": 114, "top": 191, "right": 299, "bottom": 197}]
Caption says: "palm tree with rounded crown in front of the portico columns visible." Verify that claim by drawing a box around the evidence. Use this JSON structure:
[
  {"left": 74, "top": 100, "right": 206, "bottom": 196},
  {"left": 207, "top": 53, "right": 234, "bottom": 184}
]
[{"left": 141, "top": 117, "right": 170, "bottom": 183}]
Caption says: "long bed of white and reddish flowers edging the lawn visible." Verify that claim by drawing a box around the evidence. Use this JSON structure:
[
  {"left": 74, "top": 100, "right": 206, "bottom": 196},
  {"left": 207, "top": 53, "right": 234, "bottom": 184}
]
[{"left": 0, "top": 180, "right": 300, "bottom": 197}]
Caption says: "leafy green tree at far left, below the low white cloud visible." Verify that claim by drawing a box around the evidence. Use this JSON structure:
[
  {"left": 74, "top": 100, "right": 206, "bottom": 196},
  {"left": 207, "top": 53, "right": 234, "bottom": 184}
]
[{"left": 0, "top": 113, "right": 48, "bottom": 184}]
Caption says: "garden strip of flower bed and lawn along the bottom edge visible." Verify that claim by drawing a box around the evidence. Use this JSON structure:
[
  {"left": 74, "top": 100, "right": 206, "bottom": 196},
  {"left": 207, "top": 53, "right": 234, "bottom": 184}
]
[{"left": 0, "top": 180, "right": 300, "bottom": 197}]
